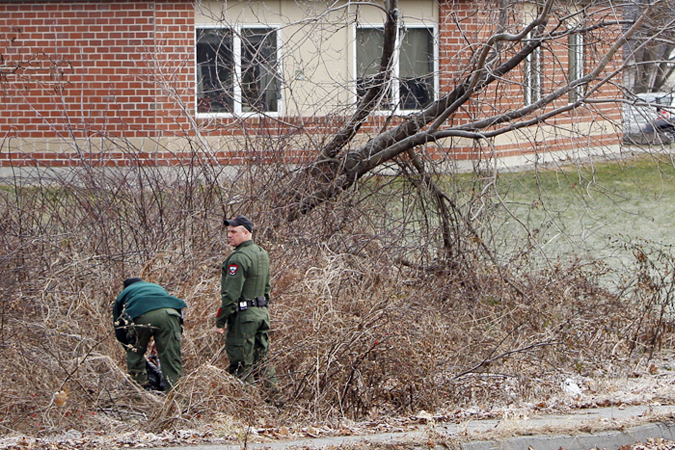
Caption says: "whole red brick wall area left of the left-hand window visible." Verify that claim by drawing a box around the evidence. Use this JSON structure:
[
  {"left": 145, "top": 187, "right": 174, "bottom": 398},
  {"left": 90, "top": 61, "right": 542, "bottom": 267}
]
[{"left": 0, "top": 1, "right": 193, "bottom": 165}]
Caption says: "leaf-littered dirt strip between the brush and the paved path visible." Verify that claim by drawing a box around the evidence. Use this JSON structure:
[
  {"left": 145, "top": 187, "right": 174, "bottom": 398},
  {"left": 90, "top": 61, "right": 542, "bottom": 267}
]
[{"left": 0, "top": 366, "right": 675, "bottom": 450}]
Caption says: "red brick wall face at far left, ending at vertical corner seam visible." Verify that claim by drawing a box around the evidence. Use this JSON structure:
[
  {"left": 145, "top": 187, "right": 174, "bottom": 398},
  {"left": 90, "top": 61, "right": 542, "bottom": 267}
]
[{"left": 0, "top": 1, "right": 166, "bottom": 138}]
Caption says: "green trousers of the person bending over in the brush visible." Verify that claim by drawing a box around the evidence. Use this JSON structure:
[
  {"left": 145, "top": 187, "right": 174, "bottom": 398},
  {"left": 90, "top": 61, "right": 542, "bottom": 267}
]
[{"left": 127, "top": 308, "right": 183, "bottom": 391}]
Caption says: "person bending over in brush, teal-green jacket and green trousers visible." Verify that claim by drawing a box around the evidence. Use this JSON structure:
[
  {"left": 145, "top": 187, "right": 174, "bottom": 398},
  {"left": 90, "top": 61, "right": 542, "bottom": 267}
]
[{"left": 113, "top": 278, "right": 187, "bottom": 391}]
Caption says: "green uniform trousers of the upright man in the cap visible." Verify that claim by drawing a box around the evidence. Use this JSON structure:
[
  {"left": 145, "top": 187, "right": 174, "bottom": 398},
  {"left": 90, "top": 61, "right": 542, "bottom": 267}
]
[{"left": 225, "top": 307, "right": 277, "bottom": 390}]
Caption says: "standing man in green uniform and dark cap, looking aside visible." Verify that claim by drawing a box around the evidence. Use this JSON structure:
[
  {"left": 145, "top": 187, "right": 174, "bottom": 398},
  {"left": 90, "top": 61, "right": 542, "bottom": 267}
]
[{"left": 215, "top": 216, "right": 277, "bottom": 394}]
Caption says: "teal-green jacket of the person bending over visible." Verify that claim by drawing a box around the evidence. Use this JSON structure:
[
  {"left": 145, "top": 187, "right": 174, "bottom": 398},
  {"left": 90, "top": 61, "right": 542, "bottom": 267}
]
[{"left": 113, "top": 281, "right": 187, "bottom": 342}]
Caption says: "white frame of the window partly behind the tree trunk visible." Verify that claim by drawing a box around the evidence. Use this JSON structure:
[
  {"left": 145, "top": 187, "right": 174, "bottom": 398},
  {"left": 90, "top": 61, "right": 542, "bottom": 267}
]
[{"left": 352, "top": 23, "right": 440, "bottom": 115}]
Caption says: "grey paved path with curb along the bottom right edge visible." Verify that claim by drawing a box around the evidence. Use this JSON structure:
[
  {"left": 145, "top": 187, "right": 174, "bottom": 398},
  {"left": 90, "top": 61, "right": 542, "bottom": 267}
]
[{"left": 153, "top": 406, "right": 675, "bottom": 450}]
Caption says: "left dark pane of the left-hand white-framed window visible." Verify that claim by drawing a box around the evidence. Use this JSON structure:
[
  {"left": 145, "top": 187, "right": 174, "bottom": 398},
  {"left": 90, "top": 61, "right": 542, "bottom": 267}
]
[{"left": 197, "top": 28, "right": 234, "bottom": 112}]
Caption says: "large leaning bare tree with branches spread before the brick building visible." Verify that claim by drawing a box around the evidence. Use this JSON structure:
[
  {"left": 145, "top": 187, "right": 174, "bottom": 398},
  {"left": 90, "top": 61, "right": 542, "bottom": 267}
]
[{"left": 235, "top": 0, "right": 656, "bottom": 255}]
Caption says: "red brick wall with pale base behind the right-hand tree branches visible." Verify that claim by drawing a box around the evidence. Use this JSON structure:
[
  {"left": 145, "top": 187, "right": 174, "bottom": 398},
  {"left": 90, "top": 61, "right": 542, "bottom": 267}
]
[{"left": 440, "top": 0, "right": 621, "bottom": 160}]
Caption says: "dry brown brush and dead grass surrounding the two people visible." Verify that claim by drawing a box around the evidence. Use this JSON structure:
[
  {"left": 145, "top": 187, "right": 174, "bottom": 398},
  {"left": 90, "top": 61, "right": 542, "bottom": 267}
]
[{"left": 0, "top": 162, "right": 672, "bottom": 441}]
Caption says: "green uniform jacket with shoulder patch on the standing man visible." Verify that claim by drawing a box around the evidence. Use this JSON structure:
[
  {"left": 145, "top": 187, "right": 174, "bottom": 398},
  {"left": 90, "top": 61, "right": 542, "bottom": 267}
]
[{"left": 216, "top": 240, "right": 270, "bottom": 328}]
